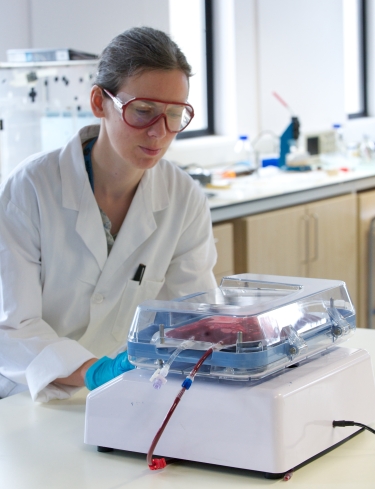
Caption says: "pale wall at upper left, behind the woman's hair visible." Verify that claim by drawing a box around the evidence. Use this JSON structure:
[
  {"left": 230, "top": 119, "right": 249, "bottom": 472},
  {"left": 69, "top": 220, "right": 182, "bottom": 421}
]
[{"left": 0, "top": 0, "right": 169, "bottom": 61}]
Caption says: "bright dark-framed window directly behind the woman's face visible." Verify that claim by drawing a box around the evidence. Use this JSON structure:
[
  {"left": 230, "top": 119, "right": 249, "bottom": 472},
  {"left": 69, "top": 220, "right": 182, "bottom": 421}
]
[{"left": 169, "top": 0, "right": 214, "bottom": 138}]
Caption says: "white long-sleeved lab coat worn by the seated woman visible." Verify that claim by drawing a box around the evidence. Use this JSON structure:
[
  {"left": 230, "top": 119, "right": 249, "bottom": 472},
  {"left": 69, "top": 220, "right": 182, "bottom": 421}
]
[{"left": 0, "top": 126, "right": 216, "bottom": 401}]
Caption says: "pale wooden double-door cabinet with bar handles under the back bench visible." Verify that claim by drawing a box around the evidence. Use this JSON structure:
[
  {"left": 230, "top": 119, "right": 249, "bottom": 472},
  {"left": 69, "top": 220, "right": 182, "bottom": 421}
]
[{"left": 233, "top": 193, "right": 364, "bottom": 310}]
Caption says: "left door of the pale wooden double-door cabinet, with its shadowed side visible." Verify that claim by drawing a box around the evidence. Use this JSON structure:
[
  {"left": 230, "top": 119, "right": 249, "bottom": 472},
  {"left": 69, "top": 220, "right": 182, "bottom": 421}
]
[{"left": 235, "top": 206, "right": 308, "bottom": 277}]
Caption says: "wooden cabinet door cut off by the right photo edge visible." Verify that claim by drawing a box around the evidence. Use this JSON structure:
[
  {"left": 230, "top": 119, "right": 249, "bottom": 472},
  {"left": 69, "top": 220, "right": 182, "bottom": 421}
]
[{"left": 357, "top": 190, "right": 375, "bottom": 327}]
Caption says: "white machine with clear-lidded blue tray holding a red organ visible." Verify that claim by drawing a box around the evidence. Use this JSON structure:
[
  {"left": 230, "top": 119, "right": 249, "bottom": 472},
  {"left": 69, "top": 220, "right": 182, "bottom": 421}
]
[{"left": 85, "top": 274, "right": 375, "bottom": 477}]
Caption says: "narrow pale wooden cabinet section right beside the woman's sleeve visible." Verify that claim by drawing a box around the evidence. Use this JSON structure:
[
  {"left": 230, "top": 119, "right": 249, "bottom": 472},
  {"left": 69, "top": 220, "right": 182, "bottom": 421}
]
[{"left": 213, "top": 222, "right": 234, "bottom": 285}]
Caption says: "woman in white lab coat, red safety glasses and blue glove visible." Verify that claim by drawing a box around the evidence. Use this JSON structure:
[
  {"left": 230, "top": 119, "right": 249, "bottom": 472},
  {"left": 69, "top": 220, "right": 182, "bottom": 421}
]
[{"left": 0, "top": 28, "right": 216, "bottom": 401}]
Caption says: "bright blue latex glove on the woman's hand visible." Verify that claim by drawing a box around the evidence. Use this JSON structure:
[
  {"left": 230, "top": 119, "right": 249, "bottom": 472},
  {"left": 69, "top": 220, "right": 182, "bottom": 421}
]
[{"left": 85, "top": 351, "right": 135, "bottom": 391}]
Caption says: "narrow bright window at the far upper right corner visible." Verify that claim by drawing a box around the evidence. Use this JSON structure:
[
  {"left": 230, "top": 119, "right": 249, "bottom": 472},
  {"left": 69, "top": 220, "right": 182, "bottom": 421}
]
[{"left": 343, "top": 0, "right": 367, "bottom": 118}]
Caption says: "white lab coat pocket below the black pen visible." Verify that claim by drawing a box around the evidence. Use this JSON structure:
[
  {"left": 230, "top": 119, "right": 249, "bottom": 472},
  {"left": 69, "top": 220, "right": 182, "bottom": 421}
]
[{"left": 112, "top": 279, "right": 165, "bottom": 344}]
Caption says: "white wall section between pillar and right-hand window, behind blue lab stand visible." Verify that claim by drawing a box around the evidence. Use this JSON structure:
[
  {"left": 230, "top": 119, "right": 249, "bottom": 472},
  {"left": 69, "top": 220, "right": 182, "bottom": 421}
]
[{"left": 258, "top": 0, "right": 346, "bottom": 134}]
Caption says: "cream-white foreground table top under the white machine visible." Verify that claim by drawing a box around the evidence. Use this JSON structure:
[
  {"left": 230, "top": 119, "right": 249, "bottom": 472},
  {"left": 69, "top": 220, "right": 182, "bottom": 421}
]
[{"left": 0, "top": 330, "right": 375, "bottom": 489}]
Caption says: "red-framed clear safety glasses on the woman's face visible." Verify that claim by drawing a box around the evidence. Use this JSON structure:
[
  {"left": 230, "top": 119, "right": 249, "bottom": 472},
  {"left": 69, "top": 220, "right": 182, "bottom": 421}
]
[{"left": 102, "top": 88, "right": 194, "bottom": 133}]
